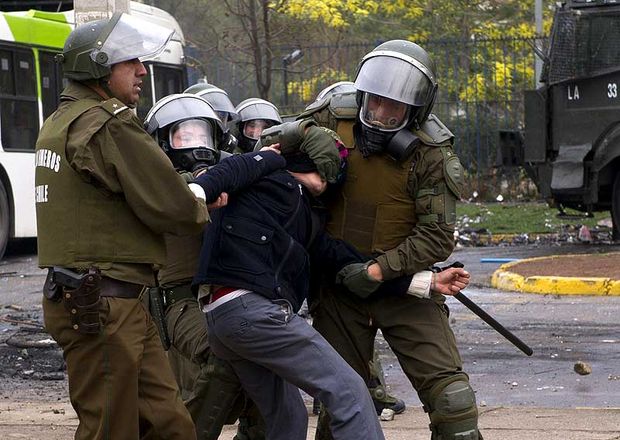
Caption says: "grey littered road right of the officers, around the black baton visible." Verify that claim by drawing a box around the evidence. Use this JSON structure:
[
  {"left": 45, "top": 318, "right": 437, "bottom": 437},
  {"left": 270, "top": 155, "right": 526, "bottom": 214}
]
[{"left": 378, "top": 244, "right": 620, "bottom": 408}]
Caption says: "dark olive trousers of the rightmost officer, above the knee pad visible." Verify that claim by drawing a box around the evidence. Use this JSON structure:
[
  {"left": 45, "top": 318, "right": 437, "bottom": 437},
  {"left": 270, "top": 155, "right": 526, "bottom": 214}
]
[{"left": 311, "top": 287, "right": 468, "bottom": 440}]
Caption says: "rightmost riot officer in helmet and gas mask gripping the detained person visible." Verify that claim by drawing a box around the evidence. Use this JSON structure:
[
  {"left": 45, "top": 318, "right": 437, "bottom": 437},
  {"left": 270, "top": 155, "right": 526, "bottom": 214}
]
[{"left": 302, "top": 40, "right": 481, "bottom": 440}]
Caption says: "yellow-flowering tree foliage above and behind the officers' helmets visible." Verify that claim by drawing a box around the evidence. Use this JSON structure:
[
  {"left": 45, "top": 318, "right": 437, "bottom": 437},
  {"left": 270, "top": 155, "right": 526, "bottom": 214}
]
[{"left": 148, "top": 0, "right": 551, "bottom": 106}]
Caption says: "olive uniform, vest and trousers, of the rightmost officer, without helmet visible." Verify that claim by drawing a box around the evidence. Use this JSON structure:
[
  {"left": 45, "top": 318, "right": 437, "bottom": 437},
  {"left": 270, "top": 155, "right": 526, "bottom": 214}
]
[{"left": 304, "top": 98, "right": 475, "bottom": 439}]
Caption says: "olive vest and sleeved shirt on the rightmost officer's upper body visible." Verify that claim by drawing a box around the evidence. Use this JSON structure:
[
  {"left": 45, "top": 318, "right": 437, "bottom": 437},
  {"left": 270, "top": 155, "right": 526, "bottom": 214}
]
[{"left": 312, "top": 115, "right": 461, "bottom": 280}]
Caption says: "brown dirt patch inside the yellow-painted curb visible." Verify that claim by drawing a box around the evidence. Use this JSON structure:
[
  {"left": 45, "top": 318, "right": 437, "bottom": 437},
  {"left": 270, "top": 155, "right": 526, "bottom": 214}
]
[{"left": 510, "top": 253, "right": 620, "bottom": 280}]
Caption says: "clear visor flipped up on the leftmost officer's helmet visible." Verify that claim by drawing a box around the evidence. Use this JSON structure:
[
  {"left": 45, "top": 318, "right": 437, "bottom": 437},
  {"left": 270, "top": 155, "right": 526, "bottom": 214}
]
[{"left": 90, "top": 14, "right": 174, "bottom": 67}]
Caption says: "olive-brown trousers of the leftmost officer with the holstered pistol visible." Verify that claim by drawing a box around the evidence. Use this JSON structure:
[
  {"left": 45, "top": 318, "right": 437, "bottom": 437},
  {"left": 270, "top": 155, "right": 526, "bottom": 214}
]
[{"left": 43, "top": 297, "right": 196, "bottom": 440}]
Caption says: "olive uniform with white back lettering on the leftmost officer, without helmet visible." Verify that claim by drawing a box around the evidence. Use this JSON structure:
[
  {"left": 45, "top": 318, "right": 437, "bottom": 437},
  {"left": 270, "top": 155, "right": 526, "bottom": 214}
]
[{"left": 35, "top": 82, "right": 208, "bottom": 440}]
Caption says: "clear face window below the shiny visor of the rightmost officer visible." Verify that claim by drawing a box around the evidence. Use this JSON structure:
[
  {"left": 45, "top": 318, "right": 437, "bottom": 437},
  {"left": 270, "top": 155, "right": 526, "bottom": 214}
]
[{"left": 360, "top": 93, "right": 411, "bottom": 131}]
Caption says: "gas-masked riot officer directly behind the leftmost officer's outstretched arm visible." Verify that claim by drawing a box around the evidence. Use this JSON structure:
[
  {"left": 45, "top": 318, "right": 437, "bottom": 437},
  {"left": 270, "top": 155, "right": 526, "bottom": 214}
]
[{"left": 144, "top": 93, "right": 264, "bottom": 440}]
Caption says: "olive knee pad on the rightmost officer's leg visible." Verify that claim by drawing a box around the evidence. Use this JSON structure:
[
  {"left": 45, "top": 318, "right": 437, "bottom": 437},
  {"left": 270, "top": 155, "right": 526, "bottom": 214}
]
[{"left": 429, "top": 375, "right": 482, "bottom": 440}]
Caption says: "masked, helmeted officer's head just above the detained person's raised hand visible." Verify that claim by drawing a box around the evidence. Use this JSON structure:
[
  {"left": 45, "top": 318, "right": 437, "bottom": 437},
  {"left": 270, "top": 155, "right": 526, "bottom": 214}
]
[{"left": 235, "top": 98, "right": 282, "bottom": 153}]
